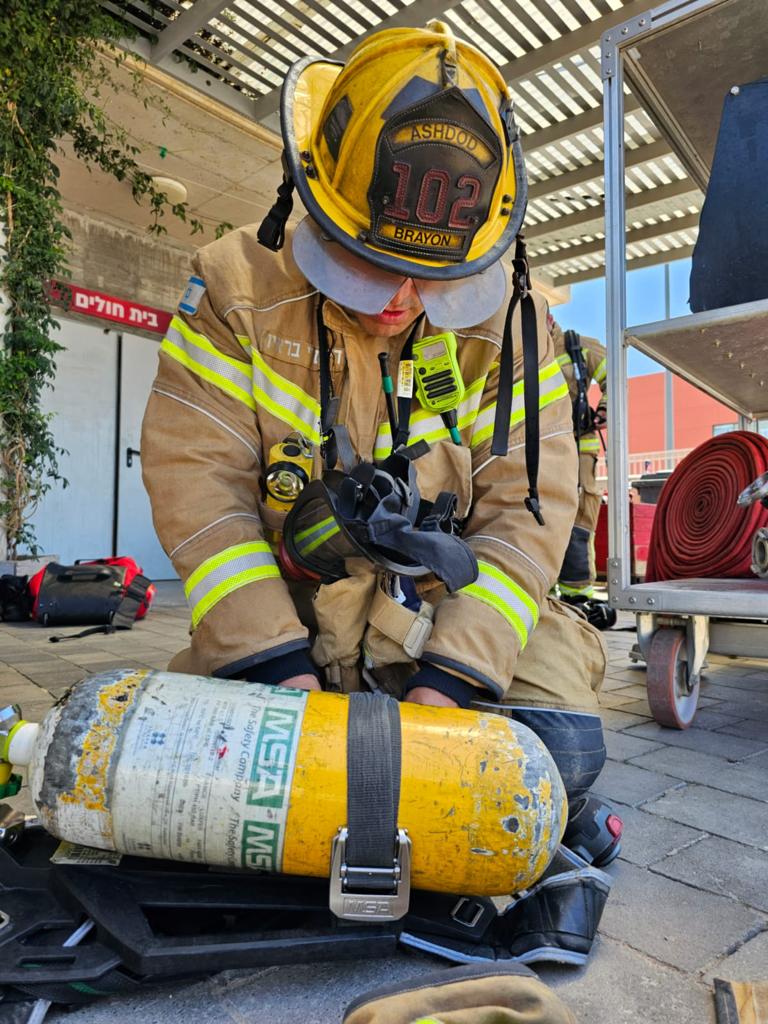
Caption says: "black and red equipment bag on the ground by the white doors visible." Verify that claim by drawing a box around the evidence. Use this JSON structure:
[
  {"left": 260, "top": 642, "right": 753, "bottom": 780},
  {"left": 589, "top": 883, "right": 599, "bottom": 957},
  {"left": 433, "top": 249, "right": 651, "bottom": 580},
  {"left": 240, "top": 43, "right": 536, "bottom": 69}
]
[{"left": 33, "top": 562, "right": 151, "bottom": 631}]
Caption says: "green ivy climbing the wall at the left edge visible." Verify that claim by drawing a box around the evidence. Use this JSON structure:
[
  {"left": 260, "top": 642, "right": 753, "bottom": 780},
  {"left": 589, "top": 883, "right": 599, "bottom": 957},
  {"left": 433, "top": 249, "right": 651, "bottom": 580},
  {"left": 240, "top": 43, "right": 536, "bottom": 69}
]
[{"left": 0, "top": 0, "right": 231, "bottom": 558}]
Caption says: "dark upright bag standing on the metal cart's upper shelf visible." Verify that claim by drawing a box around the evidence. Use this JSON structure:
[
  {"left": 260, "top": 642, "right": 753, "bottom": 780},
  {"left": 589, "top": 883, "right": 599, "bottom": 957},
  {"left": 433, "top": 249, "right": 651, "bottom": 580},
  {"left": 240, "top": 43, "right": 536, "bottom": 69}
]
[{"left": 690, "top": 79, "right": 768, "bottom": 312}]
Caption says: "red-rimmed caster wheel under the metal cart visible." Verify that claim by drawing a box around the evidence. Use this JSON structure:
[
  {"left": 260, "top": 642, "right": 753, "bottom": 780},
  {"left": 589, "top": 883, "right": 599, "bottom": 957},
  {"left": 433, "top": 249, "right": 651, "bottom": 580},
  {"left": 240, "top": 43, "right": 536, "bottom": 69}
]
[{"left": 646, "top": 629, "right": 698, "bottom": 729}]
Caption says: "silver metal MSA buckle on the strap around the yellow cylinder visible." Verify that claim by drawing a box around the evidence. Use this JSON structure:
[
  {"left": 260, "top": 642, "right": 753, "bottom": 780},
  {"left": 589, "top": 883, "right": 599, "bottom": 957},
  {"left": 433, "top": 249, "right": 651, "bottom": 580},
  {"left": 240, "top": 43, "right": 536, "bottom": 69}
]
[{"left": 330, "top": 828, "right": 411, "bottom": 923}]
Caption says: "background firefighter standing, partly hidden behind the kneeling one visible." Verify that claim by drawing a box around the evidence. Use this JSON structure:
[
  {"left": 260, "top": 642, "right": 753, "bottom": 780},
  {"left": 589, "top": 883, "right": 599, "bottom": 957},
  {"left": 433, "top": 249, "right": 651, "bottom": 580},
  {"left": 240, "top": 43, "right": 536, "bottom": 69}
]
[{"left": 547, "top": 313, "right": 615, "bottom": 629}]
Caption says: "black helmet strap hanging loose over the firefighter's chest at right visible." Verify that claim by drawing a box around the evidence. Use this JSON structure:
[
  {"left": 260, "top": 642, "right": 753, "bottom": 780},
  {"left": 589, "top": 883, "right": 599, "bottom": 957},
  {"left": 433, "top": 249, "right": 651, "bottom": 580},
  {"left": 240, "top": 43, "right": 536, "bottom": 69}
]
[{"left": 490, "top": 234, "right": 544, "bottom": 526}]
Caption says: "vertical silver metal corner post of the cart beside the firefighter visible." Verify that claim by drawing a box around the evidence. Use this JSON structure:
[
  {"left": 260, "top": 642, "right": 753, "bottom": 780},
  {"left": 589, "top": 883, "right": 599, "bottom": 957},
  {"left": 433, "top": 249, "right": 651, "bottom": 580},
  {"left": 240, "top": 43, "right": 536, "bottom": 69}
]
[{"left": 601, "top": 32, "right": 631, "bottom": 604}]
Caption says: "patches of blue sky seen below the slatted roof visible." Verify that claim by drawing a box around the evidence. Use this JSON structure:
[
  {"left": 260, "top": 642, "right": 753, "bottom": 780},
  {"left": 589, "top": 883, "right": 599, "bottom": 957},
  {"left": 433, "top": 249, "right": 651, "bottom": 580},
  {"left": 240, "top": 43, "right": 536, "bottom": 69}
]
[{"left": 552, "top": 259, "right": 690, "bottom": 377}]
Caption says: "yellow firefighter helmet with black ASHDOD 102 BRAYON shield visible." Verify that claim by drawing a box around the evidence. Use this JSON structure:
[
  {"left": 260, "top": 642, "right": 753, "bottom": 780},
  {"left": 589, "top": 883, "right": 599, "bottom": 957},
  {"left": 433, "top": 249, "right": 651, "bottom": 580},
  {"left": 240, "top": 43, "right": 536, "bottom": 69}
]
[{"left": 262, "top": 22, "right": 527, "bottom": 321}]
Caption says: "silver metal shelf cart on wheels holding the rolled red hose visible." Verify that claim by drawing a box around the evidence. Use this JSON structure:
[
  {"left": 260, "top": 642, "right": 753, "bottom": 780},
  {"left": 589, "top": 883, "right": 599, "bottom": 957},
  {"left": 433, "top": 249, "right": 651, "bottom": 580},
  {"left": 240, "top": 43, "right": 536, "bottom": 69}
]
[{"left": 601, "top": 0, "right": 768, "bottom": 729}]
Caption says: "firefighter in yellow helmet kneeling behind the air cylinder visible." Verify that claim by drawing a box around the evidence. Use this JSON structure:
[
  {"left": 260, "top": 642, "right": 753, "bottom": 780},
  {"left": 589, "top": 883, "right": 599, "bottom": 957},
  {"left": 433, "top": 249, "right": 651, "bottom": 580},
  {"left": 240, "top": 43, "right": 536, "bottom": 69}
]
[{"left": 141, "top": 23, "right": 617, "bottom": 860}]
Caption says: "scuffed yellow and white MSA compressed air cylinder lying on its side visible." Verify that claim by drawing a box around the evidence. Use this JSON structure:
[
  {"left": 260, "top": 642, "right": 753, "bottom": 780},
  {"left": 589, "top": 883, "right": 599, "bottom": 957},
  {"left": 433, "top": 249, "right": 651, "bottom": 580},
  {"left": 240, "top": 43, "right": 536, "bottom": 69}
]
[{"left": 6, "top": 670, "right": 566, "bottom": 896}]
